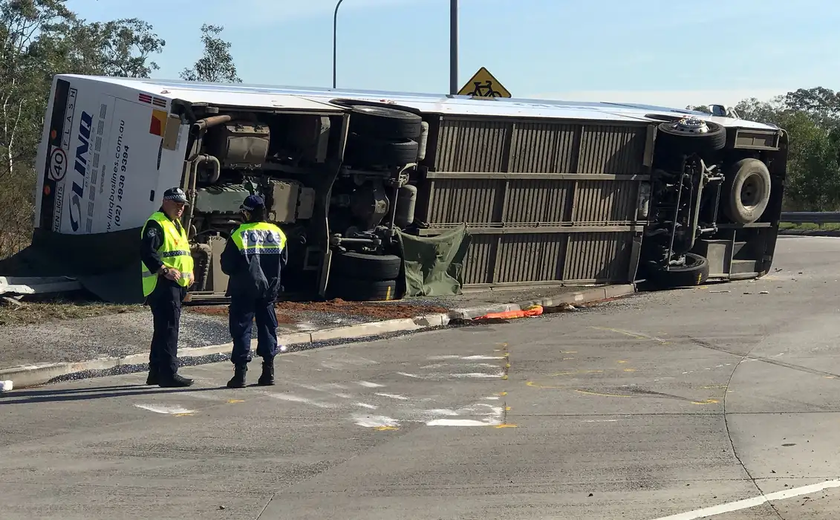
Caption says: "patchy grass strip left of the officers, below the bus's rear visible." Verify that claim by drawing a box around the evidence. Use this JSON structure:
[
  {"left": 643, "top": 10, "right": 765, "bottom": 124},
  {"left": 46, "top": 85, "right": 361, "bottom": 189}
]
[{"left": 0, "top": 298, "right": 144, "bottom": 327}]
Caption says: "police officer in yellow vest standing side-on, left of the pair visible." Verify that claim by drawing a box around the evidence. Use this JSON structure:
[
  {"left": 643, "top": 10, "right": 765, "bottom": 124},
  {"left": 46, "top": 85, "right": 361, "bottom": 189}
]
[{"left": 140, "top": 187, "right": 193, "bottom": 387}]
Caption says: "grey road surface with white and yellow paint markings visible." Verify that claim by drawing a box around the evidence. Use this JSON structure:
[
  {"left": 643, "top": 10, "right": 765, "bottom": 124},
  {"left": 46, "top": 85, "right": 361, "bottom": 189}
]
[{"left": 0, "top": 237, "right": 840, "bottom": 520}]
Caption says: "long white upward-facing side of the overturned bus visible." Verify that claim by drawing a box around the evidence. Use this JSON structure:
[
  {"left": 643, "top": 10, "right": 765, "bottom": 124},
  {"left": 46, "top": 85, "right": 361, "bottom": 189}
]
[{"left": 58, "top": 74, "right": 776, "bottom": 129}]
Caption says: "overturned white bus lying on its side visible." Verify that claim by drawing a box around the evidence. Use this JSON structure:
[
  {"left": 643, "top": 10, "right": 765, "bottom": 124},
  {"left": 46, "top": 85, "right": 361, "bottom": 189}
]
[{"left": 27, "top": 75, "right": 787, "bottom": 300}]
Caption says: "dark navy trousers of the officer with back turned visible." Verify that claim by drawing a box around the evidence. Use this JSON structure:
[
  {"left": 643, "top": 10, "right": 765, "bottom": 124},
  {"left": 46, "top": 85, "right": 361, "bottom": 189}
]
[{"left": 229, "top": 296, "right": 277, "bottom": 366}]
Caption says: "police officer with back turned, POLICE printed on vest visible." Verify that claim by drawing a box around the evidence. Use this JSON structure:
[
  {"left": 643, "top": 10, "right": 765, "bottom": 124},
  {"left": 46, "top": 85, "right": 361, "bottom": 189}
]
[{"left": 220, "top": 195, "right": 288, "bottom": 388}]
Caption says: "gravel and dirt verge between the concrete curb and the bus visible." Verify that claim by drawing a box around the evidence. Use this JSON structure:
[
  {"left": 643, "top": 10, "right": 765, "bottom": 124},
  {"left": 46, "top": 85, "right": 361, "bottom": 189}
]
[{"left": 0, "top": 287, "right": 592, "bottom": 368}]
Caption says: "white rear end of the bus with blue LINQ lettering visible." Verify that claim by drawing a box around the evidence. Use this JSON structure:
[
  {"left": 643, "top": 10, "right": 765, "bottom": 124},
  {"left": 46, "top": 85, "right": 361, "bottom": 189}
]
[{"left": 48, "top": 85, "right": 183, "bottom": 234}]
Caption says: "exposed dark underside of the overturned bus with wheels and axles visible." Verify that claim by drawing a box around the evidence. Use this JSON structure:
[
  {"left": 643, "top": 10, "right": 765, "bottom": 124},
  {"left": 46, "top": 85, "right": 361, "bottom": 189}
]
[{"left": 167, "top": 100, "right": 787, "bottom": 300}]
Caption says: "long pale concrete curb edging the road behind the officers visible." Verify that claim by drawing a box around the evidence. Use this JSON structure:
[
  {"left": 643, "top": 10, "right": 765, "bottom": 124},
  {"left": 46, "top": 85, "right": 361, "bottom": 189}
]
[{"left": 0, "top": 284, "right": 636, "bottom": 389}]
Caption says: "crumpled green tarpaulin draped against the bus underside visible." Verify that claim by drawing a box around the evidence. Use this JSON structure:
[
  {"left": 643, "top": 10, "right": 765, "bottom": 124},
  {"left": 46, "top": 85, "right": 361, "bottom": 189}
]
[{"left": 397, "top": 224, "right": 471, "bottom": 296}]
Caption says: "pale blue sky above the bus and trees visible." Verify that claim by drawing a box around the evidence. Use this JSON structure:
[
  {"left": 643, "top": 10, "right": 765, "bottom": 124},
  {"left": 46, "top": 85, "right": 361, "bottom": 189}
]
[{"left": 67, "top": 0, "right": 840, "bottom": 106}]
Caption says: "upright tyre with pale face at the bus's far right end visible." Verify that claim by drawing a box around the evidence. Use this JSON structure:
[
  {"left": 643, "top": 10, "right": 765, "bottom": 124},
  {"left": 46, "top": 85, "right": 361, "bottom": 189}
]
[{"left": 723, "top": 159, "right": 772, "bottom": 224}]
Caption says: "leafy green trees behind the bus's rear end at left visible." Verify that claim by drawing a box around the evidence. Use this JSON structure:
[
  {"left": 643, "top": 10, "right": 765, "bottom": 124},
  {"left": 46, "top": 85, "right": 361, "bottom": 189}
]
[{"left": 0, "top": 0, "right": 239, "bottom": 258}]
